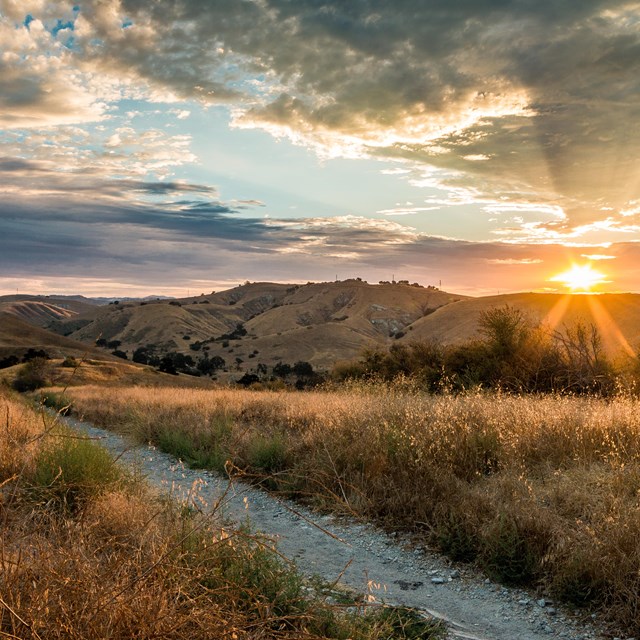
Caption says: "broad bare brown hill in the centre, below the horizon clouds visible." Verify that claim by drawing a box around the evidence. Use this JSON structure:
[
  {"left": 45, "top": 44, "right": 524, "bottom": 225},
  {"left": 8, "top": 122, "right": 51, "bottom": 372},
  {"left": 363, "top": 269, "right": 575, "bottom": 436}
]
[{"left": 51, "top": 280, "right": 461, "bottom": 371}]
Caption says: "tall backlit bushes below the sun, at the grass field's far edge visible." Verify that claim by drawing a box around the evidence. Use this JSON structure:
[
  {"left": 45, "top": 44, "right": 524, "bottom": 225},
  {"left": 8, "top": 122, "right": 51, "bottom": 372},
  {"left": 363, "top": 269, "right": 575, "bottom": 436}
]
[{"left": 333, "top": 306, "right": 621, "bottom": 395}]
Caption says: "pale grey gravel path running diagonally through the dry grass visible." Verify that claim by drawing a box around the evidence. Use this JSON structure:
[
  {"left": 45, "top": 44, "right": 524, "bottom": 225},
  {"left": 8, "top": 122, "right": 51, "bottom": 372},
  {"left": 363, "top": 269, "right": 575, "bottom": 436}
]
[{"left": 66, "top": 418, "right": 603, "bottom": 640}]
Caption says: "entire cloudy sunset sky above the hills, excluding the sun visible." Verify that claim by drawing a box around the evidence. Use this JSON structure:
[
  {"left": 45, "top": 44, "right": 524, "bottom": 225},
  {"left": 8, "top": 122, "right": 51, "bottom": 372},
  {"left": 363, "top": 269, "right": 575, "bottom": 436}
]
[{"left": 0, "top": 0, "right": 640, "bottom": 296}]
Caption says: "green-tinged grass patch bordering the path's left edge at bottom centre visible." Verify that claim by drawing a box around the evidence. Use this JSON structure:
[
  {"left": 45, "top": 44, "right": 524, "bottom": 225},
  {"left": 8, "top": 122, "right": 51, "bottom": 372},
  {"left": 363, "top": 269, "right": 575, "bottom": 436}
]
[{"left": 182, "top": 514, "right": 445, "bottom": 640}]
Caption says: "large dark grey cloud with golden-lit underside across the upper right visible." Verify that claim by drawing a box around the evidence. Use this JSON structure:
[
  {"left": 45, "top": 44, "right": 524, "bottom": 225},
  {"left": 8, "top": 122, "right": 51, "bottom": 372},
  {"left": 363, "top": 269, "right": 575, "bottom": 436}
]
[{"left": 87, "top": 0, "right": 640, "bottom": 235}]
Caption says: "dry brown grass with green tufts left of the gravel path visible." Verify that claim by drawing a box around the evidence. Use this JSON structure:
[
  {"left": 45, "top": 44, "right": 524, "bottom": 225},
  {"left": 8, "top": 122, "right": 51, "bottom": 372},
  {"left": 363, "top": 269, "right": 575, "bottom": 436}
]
[{"left": 0, "top": 388, "right": 442, "bottom": 640}]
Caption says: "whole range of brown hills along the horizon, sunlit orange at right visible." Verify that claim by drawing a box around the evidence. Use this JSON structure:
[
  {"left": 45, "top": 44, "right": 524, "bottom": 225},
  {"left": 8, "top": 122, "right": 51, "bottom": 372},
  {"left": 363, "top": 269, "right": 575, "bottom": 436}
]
[{"left": 8, "top": 279, "right": 640, "bottom": 373}]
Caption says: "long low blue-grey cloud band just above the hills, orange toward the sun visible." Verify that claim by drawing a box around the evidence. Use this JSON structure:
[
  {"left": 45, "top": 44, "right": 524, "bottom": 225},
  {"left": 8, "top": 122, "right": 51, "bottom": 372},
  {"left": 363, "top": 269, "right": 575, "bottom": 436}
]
[{"left": 0, "top": 172, "right": 640, "bottom": 294}]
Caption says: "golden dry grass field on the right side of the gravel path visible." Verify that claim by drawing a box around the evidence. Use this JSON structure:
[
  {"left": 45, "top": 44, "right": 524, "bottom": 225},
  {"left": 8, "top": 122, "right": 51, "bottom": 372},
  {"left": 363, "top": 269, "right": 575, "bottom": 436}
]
[{"left": 65, "top": 386, "right": 640, "bottom": 635}]
